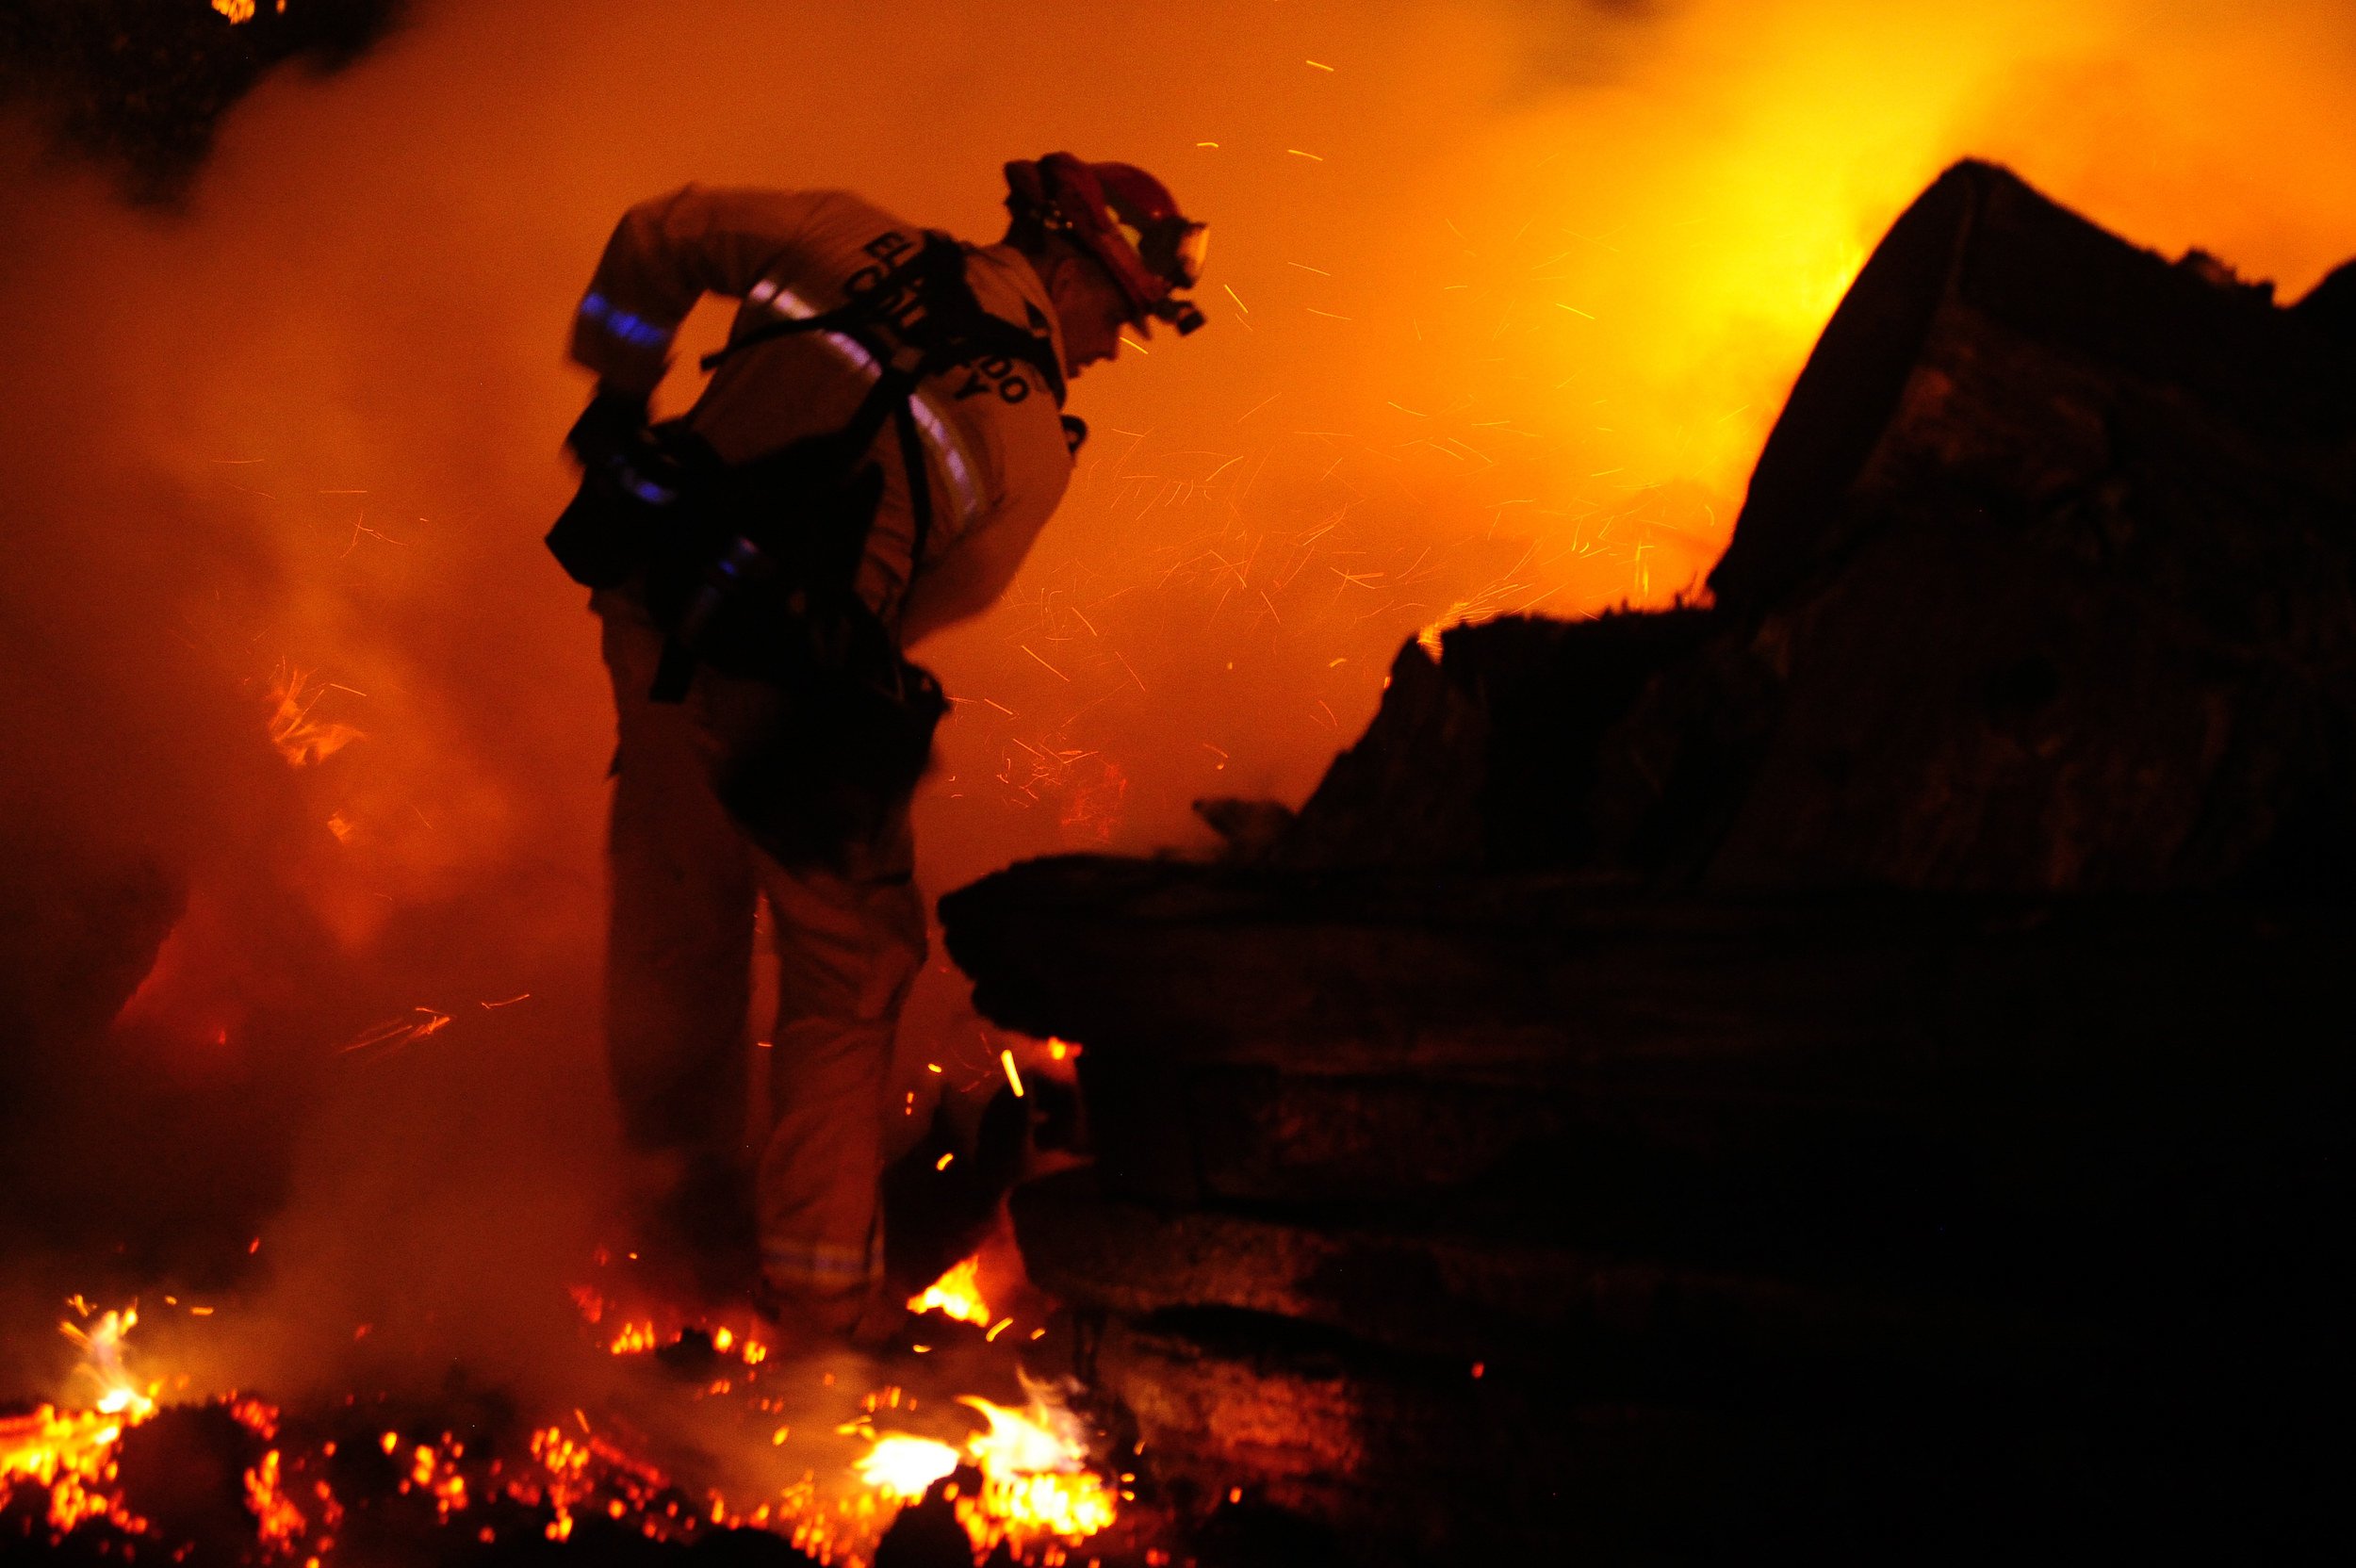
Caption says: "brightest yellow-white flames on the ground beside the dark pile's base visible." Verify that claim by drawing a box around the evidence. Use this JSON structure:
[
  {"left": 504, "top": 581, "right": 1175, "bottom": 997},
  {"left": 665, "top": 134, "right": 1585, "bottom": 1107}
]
[{"left": 858, "top": 1375, "right": 1117, "bottom": 1552}]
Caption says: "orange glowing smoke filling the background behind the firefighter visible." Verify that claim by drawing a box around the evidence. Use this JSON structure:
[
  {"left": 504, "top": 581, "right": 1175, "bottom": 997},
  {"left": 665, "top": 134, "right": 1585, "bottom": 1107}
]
[{"left": 0, "top": 0, "right": 2356, "bottom": 1387}]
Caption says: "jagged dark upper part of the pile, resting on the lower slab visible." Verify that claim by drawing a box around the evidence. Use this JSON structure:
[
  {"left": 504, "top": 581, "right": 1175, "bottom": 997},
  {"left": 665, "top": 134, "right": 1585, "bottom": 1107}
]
[{"left": 1270, "top": 162, "right": 2356, "bottom": 892}]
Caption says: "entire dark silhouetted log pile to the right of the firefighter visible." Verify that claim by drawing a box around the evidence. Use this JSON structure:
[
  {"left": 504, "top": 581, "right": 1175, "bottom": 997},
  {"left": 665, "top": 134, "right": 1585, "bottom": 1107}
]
[{"left": 941, "top": 162, "right": 2356, "bottom": 1563}]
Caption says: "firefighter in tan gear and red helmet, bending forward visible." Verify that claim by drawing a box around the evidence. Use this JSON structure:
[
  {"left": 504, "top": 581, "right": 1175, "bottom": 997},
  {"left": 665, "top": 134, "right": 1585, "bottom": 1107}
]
[{"left": 549, "top": 153, "right": 1206, "bottom": 1335}]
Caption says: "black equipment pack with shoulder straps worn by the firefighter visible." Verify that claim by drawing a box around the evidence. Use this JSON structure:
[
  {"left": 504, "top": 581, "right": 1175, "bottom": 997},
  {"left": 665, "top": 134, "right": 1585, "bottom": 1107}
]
[{"left": 547, "top": 236, "right": 1065, "bottom": 869}]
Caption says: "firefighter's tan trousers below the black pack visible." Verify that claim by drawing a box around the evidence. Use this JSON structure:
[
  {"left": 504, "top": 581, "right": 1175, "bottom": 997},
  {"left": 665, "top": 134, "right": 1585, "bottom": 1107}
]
[{"left": 592, "top": 591, "right": 926, "bottom": 1312}]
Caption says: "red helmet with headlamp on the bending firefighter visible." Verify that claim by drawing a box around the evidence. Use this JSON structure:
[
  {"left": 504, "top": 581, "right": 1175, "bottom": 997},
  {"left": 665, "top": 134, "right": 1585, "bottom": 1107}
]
[{"left": 1006, "top": 153, "right": 1211, "bottom": 336}]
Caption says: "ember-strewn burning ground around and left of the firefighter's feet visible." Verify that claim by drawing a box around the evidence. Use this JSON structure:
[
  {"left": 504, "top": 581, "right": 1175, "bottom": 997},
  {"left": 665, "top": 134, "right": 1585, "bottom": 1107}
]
[{"left": 0, "top": 1257, "right": 1162, "bottom": 1566}]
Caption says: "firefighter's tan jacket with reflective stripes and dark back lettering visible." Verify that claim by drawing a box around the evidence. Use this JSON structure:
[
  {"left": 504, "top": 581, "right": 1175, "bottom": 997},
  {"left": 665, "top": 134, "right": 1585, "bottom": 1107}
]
[{"left": 573, "top": 186, "right": 1072, "bottom": 643}]
